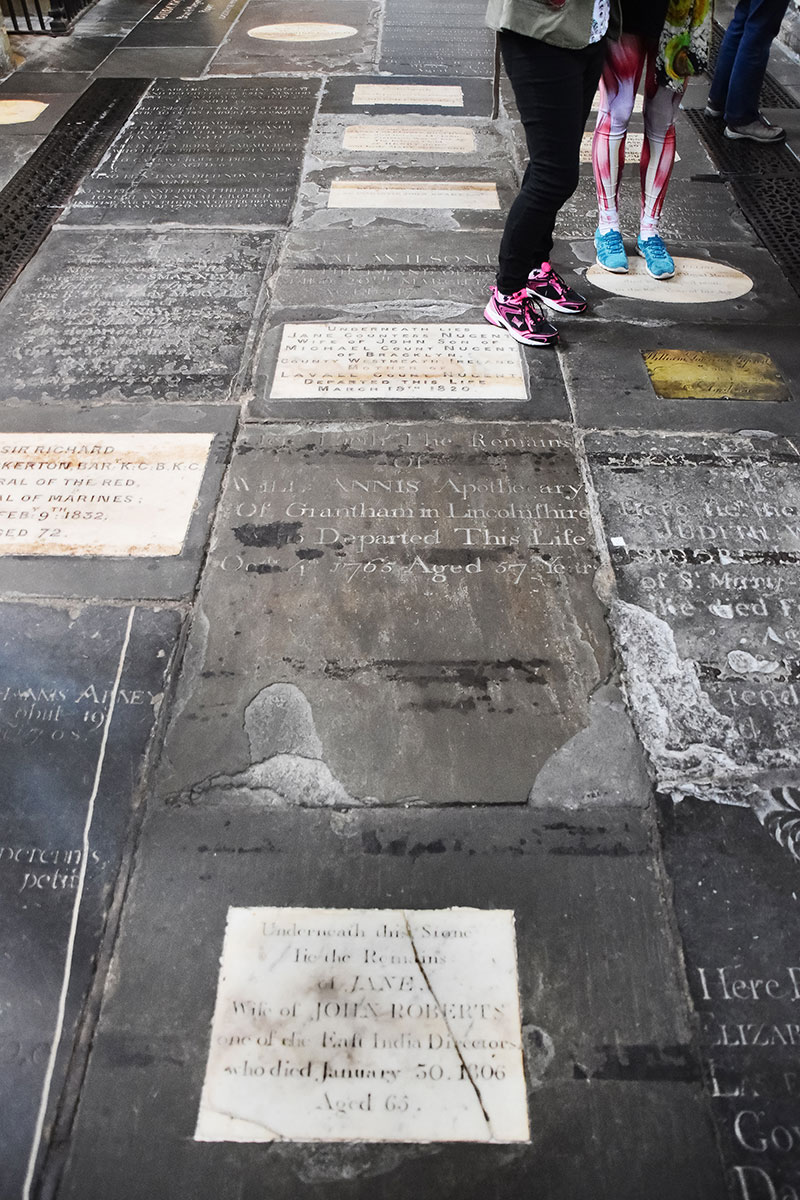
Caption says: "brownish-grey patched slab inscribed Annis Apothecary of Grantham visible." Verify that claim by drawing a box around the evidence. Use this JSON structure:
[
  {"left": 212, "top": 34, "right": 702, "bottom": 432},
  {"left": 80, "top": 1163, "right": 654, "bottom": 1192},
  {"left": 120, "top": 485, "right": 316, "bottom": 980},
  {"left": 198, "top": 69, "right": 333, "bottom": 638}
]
[{"left": 158, "top": 422, "right": 610, "bottom": 808}]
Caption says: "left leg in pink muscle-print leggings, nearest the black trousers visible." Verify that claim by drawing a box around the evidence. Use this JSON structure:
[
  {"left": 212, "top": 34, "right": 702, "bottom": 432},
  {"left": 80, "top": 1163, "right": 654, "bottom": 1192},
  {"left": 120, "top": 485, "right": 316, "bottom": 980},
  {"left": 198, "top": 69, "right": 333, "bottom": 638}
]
[{"left": 591, "top": 34, "right": 645, "bottom": 236}]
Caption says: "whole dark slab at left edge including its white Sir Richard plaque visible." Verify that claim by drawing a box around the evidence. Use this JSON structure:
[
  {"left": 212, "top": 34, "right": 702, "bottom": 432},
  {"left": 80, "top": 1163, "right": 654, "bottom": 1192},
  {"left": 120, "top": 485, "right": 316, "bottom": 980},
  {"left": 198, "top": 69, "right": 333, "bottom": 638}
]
[{"left": 0, "top": 404, "right": 239, "bottom": 599}]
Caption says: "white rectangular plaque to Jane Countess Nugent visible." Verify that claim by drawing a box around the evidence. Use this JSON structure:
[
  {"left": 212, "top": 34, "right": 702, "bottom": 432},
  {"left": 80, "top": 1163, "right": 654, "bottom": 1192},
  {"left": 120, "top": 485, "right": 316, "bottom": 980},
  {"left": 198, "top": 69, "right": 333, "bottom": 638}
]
[{"left": 271, "top": 322, "right": 528, "bottom": 401}]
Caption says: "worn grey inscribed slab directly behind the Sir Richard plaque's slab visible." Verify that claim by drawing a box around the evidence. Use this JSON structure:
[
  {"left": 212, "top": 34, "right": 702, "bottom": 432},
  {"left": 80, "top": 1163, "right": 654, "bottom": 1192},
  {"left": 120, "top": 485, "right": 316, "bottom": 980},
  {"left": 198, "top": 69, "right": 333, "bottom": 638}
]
[{"left": 0, "top": 229, "right": 272, "bottom": 406}]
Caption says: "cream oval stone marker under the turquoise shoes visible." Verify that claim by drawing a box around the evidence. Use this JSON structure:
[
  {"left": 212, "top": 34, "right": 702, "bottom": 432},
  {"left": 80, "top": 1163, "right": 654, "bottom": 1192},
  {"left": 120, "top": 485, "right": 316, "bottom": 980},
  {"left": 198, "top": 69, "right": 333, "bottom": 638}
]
[{"left": 587, "top": 254, "right": 753, "bottom": 304}]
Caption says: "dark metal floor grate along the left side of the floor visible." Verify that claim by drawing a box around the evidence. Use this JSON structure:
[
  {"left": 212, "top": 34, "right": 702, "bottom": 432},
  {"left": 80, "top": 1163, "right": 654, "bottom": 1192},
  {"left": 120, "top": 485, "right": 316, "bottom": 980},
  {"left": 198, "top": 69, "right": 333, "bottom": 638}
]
[{"left": 0, "top": 79, "right": 151, "bottom": 296}]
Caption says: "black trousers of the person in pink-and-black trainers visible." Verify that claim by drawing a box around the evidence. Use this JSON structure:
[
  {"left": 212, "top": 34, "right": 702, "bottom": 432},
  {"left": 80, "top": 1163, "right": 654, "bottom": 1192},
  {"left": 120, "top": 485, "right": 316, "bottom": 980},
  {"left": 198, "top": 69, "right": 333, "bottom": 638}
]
[{"left": 498, "top": 30, "right": 606, "bottom": 295}]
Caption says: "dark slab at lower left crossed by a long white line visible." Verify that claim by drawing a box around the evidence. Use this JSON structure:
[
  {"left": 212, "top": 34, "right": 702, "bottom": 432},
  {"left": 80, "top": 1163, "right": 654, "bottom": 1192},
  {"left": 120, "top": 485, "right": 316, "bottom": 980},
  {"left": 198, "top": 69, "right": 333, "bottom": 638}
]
[{"left": 0, "top": 605, "right": 179, "bottom": 1200}]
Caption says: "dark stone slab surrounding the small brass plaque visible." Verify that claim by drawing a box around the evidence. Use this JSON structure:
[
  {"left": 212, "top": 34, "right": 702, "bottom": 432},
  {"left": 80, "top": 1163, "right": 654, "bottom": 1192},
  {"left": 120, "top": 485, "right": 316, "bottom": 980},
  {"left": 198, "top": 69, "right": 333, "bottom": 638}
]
[{"left": 564, "top": 319, "right": 800, "bottom": 434}]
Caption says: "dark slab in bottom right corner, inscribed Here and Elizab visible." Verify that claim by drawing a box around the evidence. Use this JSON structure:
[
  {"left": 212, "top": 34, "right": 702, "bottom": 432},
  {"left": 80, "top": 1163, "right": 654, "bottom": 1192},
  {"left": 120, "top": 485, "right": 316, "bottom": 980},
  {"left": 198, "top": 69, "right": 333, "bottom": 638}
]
[{"left": 661, "top": 796, "right": 800, "bottom": 1198}]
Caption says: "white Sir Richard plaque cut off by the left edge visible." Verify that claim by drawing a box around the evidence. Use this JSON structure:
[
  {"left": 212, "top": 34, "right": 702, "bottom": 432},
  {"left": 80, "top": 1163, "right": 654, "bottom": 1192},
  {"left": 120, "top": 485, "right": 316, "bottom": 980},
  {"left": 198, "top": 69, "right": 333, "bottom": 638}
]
[{"left": 0, "top": 433, "right": 212, "bottom": 557}]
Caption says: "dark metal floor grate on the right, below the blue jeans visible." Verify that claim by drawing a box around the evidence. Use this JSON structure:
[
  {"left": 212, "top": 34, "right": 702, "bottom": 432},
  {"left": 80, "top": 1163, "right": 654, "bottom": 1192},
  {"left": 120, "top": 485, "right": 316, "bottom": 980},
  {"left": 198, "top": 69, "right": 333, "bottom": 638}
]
[{"left": 686, "top": 109, "right": 800, "bottom": 295}]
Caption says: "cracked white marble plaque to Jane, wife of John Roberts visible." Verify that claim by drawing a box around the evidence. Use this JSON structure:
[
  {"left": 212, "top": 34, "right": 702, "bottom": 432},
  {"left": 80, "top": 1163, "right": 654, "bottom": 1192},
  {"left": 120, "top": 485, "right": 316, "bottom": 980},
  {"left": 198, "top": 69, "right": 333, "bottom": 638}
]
[{"left": 194, "top": 908, "right": 529, "bottom": 1142}]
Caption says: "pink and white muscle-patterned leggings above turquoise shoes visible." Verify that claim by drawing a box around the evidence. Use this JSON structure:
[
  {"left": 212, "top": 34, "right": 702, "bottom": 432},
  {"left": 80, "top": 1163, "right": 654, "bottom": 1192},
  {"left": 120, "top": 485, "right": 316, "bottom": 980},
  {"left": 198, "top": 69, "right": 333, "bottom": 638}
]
[{"left": 591, "top": 34, "right": 682, "bottom": 239}]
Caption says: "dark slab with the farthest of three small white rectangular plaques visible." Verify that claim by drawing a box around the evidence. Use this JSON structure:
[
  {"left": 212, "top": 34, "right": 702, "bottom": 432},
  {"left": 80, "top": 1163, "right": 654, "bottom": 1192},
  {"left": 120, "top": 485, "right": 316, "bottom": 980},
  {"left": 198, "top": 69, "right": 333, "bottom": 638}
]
[{"left": 320, "top": 72, "right": 492, "bottom": 118}]
